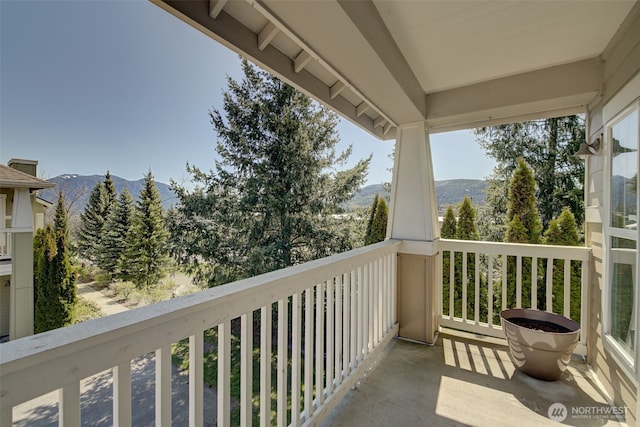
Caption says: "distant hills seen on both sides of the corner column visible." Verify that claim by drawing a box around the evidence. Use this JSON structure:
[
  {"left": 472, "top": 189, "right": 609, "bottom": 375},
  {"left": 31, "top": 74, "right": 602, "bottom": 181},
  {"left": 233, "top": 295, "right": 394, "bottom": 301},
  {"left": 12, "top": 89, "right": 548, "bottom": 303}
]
[{"left": 345, "top": 179, "right": 487, "bottom": 209}]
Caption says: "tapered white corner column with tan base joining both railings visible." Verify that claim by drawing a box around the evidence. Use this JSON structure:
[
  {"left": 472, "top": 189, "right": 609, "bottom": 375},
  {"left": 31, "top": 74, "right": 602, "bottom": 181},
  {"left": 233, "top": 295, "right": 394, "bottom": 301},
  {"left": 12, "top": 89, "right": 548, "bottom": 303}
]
[{"left": 387, "top": 122, "right": 440, "bottom": 343}]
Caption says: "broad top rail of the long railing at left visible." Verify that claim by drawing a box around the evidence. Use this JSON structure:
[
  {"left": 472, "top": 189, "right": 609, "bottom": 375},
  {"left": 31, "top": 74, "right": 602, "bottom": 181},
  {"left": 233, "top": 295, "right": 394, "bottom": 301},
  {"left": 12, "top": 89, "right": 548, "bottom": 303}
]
[{"left": 0, "top": 240, "right": 401, "bottom": 405}]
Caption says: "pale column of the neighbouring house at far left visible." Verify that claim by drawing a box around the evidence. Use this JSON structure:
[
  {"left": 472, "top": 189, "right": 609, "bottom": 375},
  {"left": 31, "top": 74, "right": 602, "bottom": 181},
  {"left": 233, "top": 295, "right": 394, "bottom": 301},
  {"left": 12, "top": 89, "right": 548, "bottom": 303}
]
[{"left": 9, "top": 189, "right": 34, "bottom": 340}]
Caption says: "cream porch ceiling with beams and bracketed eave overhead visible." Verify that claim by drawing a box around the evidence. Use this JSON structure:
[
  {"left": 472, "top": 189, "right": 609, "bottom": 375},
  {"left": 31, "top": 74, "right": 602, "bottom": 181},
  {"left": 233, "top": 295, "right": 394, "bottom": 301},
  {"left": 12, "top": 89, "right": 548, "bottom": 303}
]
[{"left": 151, "top": 0, "right": 640, "bottom": 139}]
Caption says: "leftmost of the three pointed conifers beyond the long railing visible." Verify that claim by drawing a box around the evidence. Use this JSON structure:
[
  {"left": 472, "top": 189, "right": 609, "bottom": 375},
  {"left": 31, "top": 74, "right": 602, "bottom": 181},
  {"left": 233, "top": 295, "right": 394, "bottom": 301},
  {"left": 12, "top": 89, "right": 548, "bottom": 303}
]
[{"left": 78, "top": 181, "right": 108, "bottom": 262}]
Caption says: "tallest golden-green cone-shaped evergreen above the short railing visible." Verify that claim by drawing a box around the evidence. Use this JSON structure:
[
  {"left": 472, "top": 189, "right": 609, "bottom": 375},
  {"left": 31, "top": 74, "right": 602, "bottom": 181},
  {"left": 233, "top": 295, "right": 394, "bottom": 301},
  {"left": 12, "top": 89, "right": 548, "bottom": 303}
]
[{"left": 505, "top": 158, "right": 542, "bottom": 243}]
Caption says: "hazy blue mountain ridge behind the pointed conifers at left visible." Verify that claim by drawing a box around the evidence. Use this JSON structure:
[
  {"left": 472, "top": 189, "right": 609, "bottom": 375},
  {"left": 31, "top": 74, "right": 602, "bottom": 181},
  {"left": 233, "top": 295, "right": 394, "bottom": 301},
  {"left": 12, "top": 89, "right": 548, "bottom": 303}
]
[{"left": 39, "top": 174, "right": 177, "bottom": 212}]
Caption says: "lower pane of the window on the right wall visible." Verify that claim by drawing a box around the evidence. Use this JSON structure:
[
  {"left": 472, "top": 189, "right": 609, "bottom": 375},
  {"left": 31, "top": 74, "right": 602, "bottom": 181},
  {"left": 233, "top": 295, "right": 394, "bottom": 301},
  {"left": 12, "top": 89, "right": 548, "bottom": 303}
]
[{"left": 609, "top": 237, "right": 636, "bottom": 357}]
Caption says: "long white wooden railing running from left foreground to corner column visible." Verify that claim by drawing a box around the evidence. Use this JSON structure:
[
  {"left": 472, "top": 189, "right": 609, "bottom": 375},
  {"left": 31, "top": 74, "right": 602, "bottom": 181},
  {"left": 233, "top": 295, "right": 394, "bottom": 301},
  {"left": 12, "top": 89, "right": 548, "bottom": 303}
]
[{"left": 0, "top": 241, "right": 400, "bottom": 427}]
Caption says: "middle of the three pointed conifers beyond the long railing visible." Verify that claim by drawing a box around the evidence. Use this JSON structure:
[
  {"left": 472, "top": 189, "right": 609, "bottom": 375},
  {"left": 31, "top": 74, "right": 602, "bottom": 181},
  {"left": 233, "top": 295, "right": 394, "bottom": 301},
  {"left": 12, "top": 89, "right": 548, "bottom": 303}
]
[{"left": 100, "top": 188, "right": 133, "bottom": 278}]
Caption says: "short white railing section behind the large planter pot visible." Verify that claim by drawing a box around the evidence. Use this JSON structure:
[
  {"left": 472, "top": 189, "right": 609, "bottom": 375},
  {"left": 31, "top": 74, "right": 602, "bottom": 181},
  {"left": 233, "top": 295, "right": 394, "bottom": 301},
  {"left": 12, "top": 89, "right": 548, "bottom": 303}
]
[{"left": 438, "top": 239, "right": 591, "bottom": 354}]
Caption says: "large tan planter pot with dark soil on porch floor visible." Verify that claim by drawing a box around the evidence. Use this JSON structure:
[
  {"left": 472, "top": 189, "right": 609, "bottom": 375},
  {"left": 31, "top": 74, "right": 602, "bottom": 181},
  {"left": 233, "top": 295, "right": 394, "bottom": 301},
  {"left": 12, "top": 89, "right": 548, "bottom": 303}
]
[{"left": 500, "top": 308, "right": 580, "bottom": 381}]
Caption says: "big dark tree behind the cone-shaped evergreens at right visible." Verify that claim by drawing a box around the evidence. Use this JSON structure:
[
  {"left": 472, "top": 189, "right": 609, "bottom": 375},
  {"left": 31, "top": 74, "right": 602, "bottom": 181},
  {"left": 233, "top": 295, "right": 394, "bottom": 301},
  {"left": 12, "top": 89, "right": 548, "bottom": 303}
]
[{"left": 475, "top": 116, "right": 585, "bottom": 232}]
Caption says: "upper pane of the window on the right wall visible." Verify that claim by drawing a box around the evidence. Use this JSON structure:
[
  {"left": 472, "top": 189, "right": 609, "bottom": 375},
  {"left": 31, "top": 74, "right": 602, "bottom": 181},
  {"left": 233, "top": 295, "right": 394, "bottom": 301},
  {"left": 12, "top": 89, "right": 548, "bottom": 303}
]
[{"left": 611, "top": 111, "right": 638, "bottom": 230}]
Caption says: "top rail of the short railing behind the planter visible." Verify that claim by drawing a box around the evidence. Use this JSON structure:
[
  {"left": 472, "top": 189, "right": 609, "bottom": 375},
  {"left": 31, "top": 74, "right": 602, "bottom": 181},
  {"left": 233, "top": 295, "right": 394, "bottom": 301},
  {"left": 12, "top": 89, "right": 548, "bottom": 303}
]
[{"left": 439, "top": 239, "right": 591, "bottom": 261}]
